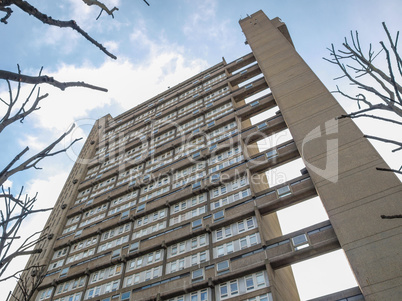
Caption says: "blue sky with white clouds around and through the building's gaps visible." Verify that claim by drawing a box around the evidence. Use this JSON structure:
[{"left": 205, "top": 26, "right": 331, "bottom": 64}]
[{"left": 0, "top": 0, "right": 402, "bottom": 300}]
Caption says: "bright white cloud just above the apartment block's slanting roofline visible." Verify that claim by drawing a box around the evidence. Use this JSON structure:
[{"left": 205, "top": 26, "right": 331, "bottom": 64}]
[{"left": 27, "top": 24, "right": 208, "bottom": 133}]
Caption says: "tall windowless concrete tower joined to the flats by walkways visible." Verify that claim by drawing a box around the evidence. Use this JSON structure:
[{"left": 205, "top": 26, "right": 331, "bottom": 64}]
[{"left": 240, "top": 11, "right": 402, "bottom": 300}]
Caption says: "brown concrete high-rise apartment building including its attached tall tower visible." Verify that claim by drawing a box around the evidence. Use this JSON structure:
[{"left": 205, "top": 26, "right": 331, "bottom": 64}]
[{"left": 14, "top": 11, "right": 402, "bottom": 301}]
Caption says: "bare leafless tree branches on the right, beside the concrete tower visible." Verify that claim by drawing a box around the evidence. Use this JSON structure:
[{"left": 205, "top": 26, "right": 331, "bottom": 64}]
[{"left": 324, "top": 23, "right": 402, "bottom": 174}]
